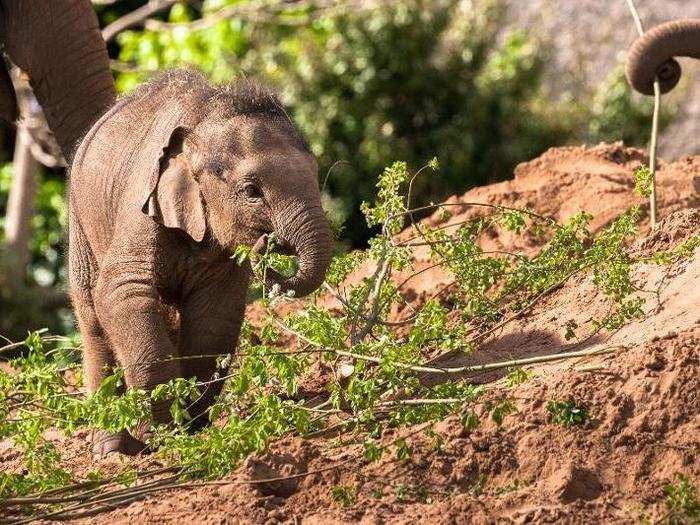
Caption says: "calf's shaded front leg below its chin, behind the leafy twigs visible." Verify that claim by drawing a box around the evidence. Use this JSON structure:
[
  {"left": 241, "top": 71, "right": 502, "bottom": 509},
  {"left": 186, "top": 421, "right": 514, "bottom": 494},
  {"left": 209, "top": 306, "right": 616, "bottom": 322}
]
[{"left": 179, "top": 261, "right": 248, "bottom": 430}]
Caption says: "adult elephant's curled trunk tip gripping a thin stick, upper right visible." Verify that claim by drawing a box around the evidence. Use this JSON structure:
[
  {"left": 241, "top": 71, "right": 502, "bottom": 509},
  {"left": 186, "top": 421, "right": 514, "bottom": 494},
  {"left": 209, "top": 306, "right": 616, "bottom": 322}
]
[{"left": 625, "top": 18, "right": 700, "bottom": 95}]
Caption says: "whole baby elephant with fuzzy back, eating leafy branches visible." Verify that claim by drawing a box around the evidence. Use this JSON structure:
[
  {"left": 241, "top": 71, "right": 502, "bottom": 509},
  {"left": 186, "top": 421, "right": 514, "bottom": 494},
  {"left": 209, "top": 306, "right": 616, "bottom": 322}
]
[{"left": 69, "top": 71, "right": 331, "bottom": 455}]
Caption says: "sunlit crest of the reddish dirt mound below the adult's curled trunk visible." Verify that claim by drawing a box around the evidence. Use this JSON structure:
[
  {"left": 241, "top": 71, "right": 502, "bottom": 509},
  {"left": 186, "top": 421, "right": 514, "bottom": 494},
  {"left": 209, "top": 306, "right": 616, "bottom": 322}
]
[{"left": 427, "top": 143, "right": 700, "bottom": 238}]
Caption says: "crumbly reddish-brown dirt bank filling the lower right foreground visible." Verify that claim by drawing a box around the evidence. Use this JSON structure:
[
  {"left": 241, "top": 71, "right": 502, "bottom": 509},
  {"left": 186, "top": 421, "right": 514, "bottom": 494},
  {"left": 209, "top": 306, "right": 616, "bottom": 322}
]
[{"left": 270, "top": 332, "right": 700, "bottom": 523}]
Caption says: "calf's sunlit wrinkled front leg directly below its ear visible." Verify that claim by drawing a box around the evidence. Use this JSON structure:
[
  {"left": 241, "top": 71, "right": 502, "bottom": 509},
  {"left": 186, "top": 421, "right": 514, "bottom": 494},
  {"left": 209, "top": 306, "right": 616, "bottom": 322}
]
[{"left": 95, "top": 237, "right": 180, "bottom": 441}]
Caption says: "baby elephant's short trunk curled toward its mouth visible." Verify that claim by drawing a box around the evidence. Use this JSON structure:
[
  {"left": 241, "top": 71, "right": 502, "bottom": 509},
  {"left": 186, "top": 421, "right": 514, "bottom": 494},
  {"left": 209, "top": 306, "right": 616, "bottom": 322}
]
[{"left": 270, "top": 205, "right": 331, "bottom": 297}]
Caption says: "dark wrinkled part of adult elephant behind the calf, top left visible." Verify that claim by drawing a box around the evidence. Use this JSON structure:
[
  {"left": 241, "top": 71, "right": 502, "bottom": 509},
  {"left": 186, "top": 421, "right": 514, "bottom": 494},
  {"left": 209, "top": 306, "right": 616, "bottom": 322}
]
[{"left": 0, "top": 0, "right": 116, "bottom": 158}]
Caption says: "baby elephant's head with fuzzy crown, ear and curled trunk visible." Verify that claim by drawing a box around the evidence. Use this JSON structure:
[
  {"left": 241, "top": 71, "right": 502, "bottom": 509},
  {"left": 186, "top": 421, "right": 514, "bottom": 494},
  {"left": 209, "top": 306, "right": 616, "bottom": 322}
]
[{"left": 143, "top": 73, "right": 331, "bottom": 296}]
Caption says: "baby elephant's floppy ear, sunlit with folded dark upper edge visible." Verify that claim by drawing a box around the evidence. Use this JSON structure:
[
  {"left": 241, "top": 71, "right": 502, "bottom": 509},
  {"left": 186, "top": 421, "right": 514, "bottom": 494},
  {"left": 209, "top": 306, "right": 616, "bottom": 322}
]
[{"left": 144, "top": 128, "right": 206, "bottom": 242}]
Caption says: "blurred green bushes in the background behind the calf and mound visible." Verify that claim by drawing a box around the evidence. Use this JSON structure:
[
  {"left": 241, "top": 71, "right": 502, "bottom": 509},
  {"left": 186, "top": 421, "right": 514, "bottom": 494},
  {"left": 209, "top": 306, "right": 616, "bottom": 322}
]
[{"left": 0, "top": 0, "right": 669, "bottom": 333}]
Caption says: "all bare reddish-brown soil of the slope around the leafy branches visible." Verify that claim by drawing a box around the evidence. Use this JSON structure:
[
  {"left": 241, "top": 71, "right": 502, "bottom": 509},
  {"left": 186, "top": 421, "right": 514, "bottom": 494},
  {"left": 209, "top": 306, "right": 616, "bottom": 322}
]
[{"left": 0, "top": 145, "right": 700, "bottom": 524}]
